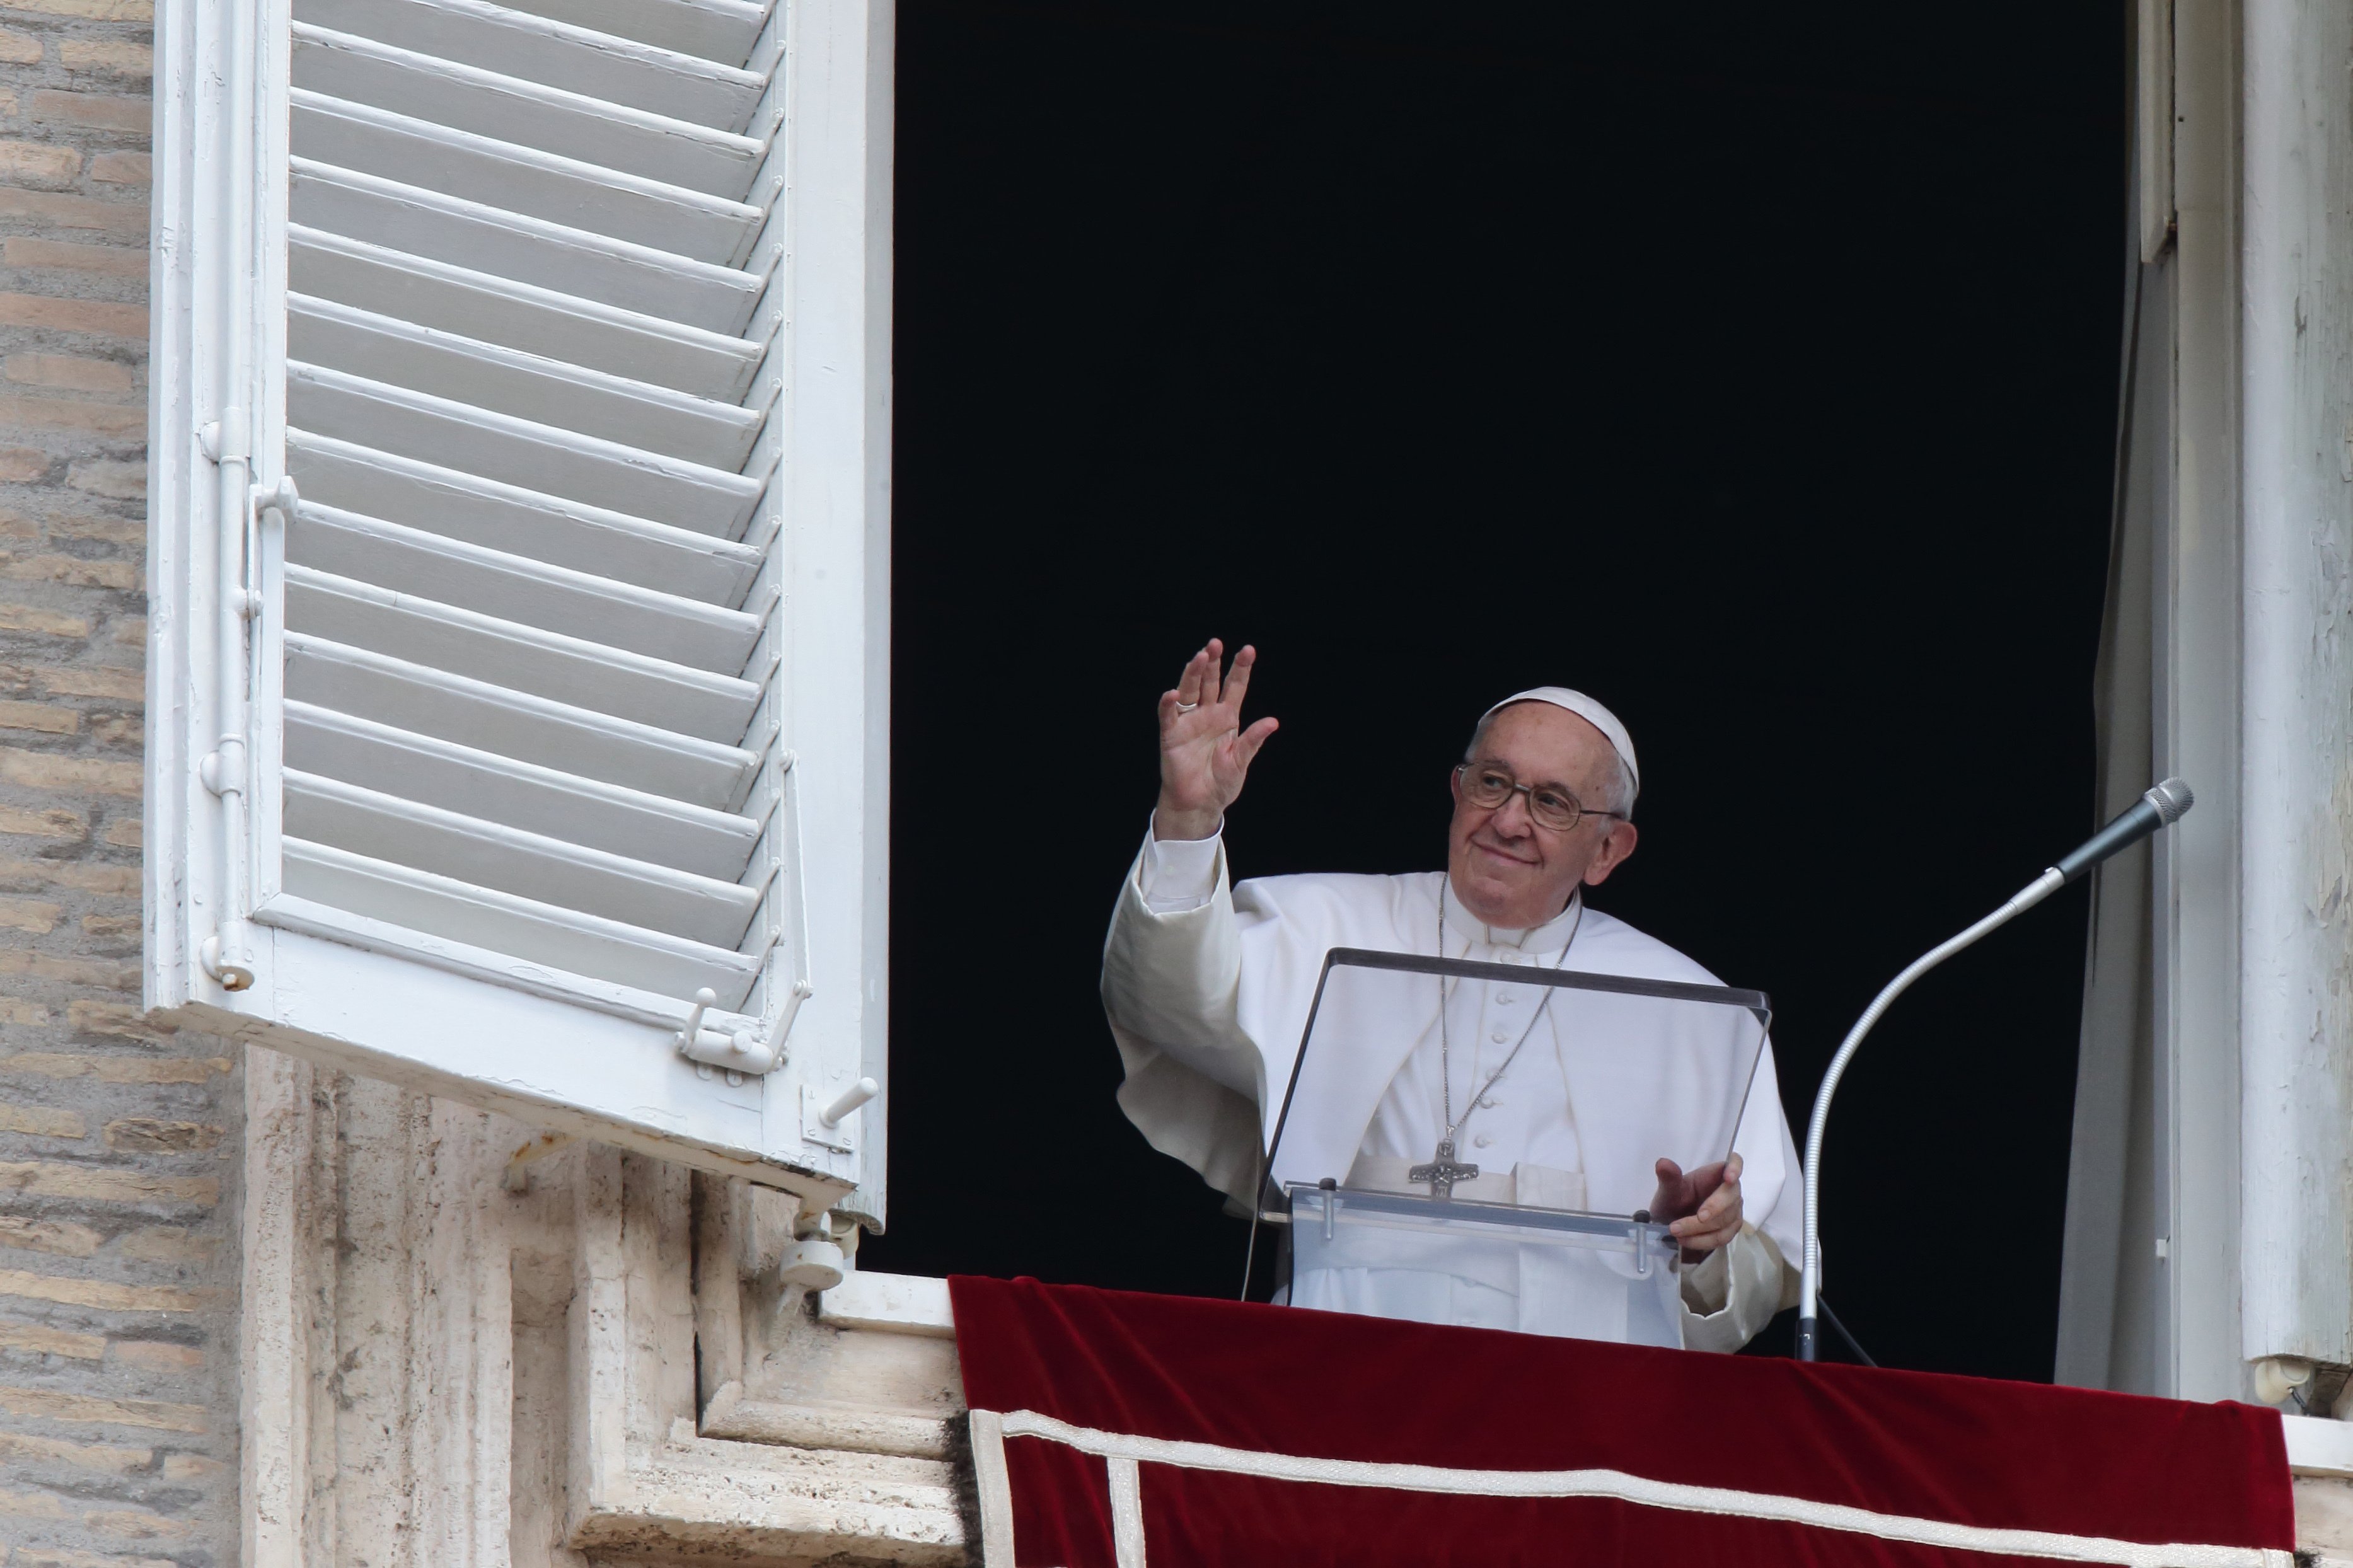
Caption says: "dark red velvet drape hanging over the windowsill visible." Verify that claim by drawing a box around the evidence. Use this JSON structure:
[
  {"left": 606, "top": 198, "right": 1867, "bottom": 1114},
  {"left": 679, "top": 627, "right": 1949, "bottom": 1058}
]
[{"left": 951, "top": 1279, "right": 2294, "bottom": 1568}]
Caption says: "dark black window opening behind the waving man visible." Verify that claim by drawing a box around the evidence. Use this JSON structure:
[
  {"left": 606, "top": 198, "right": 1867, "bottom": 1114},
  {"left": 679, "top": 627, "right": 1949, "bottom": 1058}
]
[{"left": 861, "top": 0, "right": 2127, "bottom": 1377}]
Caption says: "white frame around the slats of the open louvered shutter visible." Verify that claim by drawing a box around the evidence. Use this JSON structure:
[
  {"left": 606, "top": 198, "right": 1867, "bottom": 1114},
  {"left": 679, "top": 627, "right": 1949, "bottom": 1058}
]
[{"left": 146, "top": 0, "right": 892, "bottom": 1225}]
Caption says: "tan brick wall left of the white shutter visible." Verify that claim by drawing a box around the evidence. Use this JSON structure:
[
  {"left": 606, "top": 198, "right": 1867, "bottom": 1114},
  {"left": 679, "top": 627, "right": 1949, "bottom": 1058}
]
[{"left": 0, "top": 0, "right": 240, "bottom": 1568}]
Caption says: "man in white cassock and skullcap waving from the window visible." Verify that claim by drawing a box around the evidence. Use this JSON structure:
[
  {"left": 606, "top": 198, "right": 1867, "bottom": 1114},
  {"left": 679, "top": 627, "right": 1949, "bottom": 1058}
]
[{"left": 1104, "top": 640, "right": 1798, "bottom": 1351}]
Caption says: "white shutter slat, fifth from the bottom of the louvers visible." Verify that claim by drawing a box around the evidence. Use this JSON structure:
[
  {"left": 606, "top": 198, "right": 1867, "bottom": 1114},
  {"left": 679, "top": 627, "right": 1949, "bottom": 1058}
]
[{"left": 287, "top": 567, "right": 760, "bottom": 744}]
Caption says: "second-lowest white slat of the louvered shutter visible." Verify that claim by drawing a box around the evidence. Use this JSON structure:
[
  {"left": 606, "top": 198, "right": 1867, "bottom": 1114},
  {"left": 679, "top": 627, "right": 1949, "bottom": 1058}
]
[{"left": 285, "top": 768, "right": 760, "bottom": 942}]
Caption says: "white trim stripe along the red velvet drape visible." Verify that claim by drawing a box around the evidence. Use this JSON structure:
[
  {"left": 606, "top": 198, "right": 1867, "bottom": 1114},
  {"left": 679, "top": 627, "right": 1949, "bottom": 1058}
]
[{"left": 972, "top": 1410, "right": 2296, "bottom": 1568}]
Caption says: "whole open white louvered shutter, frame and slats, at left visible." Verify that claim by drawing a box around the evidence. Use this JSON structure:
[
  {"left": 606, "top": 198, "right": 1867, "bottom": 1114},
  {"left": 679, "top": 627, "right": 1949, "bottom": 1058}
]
[{"left": 148, "top": 0, "right": 889, "bottom": 1217}]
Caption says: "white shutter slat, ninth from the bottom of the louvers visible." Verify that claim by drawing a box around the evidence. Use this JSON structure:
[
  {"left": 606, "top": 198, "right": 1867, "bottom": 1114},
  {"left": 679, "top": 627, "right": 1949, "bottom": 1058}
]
[{"left": 287, "top": 294, "right": 767, "bottom": 471}]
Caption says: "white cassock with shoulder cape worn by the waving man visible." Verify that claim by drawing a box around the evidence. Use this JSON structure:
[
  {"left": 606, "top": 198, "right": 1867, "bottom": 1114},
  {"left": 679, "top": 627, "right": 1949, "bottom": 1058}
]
[{"left": 1104, "top": 836, "right": 1800, "bottom": 1351}]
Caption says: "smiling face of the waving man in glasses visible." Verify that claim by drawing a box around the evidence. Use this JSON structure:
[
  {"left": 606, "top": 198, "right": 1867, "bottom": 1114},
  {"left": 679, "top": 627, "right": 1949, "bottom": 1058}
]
[{"left": 1447, "top": 701, "right": 1635, "bottom": 930}]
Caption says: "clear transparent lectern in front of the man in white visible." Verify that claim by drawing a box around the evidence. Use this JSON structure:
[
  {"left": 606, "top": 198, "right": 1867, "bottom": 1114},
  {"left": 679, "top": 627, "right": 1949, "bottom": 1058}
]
[{"left": 1259, "top": 949, "right": 1772, "bottom": 1344}]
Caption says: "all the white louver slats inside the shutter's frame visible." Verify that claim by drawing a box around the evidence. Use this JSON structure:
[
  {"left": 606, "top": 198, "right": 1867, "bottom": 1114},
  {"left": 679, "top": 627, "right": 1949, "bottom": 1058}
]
[{"left": 267, "top": 0, "right": 800, "bottom": 1001}]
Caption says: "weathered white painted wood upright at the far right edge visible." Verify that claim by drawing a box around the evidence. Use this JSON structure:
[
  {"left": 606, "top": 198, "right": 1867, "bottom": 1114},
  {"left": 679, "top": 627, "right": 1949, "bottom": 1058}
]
[{"left": 2238, "top": 0, "right": 2353, "bottom": 1366}]
